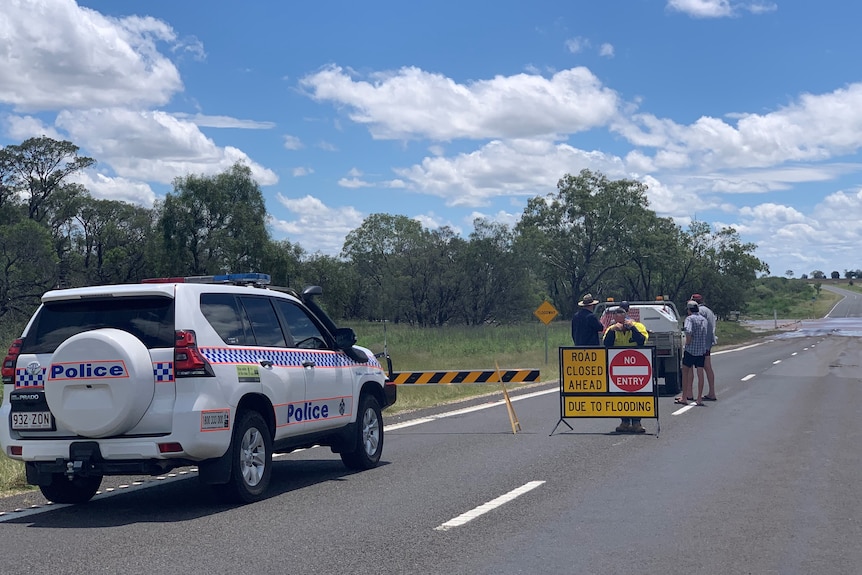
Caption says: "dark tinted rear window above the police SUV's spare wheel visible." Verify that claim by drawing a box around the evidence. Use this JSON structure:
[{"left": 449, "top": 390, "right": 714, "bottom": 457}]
[{"left": 21, "top": 297, "right": 176, "bottom": 353}]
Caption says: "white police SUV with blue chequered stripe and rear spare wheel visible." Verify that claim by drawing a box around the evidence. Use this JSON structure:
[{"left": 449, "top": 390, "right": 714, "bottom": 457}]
[{"left": 0, "top": 274, "right": 396, "bottom": 503}]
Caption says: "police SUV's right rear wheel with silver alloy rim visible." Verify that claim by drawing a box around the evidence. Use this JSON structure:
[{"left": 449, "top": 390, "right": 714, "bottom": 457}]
[{"left": 215, "top": 411, "right": 272, "bottom": 503}]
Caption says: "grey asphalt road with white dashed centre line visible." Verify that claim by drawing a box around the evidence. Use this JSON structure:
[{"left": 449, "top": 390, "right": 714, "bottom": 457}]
[{"left": 0, "top": 301, "right": 862, "bottom": 575}]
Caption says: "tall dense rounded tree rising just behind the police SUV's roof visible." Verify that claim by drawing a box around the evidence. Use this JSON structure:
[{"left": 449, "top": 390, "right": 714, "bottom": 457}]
[{"left": 158, "top": 163, "right": 270, "bottom": 275}]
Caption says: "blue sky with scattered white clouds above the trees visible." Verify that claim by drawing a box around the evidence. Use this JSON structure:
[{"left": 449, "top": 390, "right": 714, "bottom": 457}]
[{"left": 0, "top": 0, "right": 862, "bottom": 277}]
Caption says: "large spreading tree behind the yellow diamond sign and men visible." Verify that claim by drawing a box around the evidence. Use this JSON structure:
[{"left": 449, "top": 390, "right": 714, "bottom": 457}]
[{"left": 516, "top": 170, "right": 649, "bottom": 316}]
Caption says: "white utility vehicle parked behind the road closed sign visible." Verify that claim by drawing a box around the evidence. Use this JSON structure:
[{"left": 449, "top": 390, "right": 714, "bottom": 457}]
[{"left": 595, "top": 299, "right": 685, "bottom": 395}]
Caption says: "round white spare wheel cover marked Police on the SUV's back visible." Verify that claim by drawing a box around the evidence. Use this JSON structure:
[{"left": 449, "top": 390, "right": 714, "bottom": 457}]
[{"left": 45, "top": 328, "right": 155, "bottom": 437}]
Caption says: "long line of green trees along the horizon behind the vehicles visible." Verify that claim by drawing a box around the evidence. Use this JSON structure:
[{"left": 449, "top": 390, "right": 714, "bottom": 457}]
[{"left": 0, "top": 136, "right": 769, "bottom": 336}]
